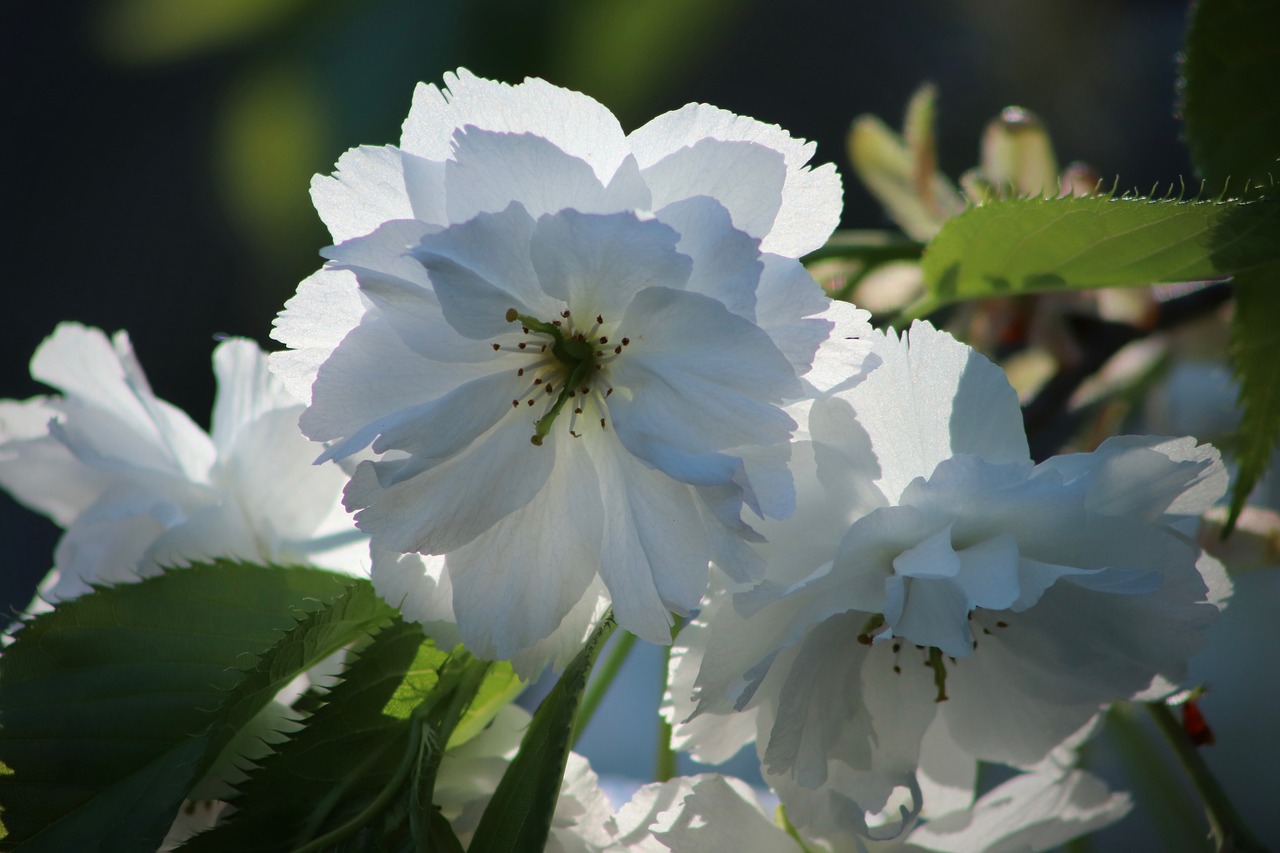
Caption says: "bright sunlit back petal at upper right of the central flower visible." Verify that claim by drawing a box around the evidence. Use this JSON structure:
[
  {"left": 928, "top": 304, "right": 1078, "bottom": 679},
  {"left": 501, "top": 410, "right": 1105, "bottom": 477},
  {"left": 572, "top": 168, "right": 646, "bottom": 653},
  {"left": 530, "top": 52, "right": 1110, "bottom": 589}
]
[{"left": 627, "top": 104, "right": 842, "bottom": 257}]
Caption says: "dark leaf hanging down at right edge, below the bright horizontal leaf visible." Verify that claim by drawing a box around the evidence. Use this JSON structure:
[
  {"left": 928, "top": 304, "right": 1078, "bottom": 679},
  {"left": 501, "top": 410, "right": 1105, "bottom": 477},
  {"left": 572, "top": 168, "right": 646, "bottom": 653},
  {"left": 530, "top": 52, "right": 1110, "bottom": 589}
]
[{"left": 1224, "top": 264, "right": 1280, "bottom": 532}]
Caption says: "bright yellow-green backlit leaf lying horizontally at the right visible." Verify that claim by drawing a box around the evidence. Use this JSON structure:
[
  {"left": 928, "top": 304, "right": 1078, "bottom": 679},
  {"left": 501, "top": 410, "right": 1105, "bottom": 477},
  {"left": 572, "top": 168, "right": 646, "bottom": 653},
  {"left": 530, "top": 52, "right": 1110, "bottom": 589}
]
[{"left": 915, "top": 196, "right": 1280, "bottom": 314}]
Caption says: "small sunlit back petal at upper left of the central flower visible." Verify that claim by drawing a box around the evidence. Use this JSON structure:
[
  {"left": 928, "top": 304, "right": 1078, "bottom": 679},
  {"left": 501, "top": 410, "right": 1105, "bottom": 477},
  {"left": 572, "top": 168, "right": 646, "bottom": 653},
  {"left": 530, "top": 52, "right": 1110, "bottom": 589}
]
[{"left": 311, "top": 146, "right": 413, "bottom": 242}]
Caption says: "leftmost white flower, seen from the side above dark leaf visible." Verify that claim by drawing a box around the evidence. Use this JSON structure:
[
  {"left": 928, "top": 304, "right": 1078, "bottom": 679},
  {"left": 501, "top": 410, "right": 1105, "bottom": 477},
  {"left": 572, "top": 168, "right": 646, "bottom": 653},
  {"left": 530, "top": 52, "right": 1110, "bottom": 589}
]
[{"left": 0, "top": 323, "right": 367, "bottom": 602}]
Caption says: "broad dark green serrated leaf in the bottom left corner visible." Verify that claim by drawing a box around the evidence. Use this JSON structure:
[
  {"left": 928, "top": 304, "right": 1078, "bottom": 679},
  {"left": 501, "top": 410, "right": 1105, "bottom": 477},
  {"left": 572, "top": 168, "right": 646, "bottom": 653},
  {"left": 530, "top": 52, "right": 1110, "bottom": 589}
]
[{"left": 0, "top": 561, "right": 392, "bottom": 853}]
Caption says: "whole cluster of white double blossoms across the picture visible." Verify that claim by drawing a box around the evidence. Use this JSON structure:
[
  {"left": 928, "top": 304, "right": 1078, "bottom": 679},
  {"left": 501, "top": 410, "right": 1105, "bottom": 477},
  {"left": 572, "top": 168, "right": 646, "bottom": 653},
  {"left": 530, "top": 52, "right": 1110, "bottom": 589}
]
[{"left": 0, "top": 70, "right": 1230, "bottom": 852}]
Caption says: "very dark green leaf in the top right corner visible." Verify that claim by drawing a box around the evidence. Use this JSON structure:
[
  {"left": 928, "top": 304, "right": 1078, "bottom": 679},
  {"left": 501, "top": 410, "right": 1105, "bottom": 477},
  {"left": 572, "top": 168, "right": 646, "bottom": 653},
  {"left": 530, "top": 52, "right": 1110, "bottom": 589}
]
[{"left": 1181, "top": 0, "right": 1280, "bottom": 195}]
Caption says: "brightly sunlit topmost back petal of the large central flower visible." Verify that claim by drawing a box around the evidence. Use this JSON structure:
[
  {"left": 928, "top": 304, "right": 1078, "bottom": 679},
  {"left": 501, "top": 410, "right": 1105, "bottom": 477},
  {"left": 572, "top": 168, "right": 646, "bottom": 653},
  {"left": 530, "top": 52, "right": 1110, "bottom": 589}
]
[{"left": 401, "top": 68, "right": 627, "bottom": 183}]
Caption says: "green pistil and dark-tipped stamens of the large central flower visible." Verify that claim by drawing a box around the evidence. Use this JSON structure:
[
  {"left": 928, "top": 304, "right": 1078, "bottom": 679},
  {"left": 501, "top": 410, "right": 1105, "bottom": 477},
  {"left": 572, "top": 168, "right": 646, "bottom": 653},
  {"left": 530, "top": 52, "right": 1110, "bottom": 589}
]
[{"left": 493, "top": 309, "right": 631, "bottom": 447}]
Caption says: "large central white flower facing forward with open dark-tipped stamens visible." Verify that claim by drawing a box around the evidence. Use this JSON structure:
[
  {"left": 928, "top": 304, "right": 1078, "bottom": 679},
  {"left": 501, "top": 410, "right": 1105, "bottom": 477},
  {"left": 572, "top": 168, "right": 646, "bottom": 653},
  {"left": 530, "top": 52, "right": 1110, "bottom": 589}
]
[{"left": 273, "top": 70, "right": 869, "bottom": 672}]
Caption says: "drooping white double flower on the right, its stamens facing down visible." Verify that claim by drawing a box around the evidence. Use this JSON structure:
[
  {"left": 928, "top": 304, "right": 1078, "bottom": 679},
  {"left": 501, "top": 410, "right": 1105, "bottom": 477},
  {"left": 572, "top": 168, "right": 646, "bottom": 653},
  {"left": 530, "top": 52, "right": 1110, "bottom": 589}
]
[{"left": 672, "top": 318, "right": 1229, "bottom": 838}]
